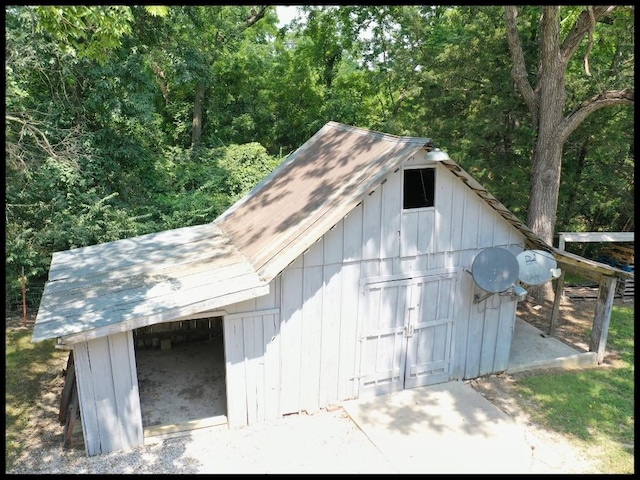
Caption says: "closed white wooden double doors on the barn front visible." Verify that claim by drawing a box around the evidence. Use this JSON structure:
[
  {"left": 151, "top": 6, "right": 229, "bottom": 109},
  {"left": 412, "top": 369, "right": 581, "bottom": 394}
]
[{"left": 359, "top": 273, "right": 457, "bottom": 398}]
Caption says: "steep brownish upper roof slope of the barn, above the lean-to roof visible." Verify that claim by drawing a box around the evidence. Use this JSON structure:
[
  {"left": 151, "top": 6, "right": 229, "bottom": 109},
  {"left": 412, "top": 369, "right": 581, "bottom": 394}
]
[{"left": 216, "top": 122, "right": 431, "bottom": 280}]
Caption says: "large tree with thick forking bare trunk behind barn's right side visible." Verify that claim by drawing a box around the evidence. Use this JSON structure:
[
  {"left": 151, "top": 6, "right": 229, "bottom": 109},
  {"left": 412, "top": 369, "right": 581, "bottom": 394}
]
[{"left": 505, "top": 5, "right": 634, "bottom": 266}]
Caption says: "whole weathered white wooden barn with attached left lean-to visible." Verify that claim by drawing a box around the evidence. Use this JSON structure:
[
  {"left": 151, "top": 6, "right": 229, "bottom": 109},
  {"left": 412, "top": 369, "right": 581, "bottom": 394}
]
[{"left": 33, "top": 122, "right": 632, "bottom": 455}]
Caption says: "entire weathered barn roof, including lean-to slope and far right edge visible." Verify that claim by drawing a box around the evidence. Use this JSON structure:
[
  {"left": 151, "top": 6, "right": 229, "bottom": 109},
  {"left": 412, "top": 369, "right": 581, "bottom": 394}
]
[{"left": 32, "top": 122, "right": 628, "bottom": 343}]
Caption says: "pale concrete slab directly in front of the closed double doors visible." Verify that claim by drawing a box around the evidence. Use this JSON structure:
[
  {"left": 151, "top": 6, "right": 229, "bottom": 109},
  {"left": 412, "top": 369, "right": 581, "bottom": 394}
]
[{"left": 342, "top": 381, "right": 532, "bottom": 473}]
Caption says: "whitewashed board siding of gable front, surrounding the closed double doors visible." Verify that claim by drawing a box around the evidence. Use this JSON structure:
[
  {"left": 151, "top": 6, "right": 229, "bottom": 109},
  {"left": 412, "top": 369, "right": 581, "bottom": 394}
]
[{"left": 225, "top": 155, "right": 524, "bottom": 426}]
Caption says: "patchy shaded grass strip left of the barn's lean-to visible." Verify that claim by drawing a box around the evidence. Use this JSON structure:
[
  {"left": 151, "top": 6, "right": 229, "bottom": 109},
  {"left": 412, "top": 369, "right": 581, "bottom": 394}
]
[{"left": 5, "top": 328, "right": 69, "bottom": 470}]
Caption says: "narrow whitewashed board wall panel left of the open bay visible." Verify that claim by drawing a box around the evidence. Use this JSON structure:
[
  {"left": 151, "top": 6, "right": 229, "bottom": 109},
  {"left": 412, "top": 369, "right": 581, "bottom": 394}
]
[{"left": 73, "top": 331, "right": 144, "bottom": 456}]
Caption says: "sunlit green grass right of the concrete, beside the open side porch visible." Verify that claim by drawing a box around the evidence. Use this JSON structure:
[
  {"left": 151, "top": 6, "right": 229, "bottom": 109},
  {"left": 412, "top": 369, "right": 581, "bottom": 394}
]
[{"left": 515, "top": 306, "right": 634, "bottom": 474}]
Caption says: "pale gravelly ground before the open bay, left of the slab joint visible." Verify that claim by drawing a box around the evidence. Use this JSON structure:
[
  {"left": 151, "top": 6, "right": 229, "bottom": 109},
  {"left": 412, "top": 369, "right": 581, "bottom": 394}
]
[{"left": 7, "top": 408, "right": 395, "bottom": 474}]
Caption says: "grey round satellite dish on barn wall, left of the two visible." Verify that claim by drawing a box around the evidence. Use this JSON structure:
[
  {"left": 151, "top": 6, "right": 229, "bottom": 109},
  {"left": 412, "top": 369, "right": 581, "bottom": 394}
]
[{"left": 471, "top": 247, "right": 519, "bottom": 293}]
